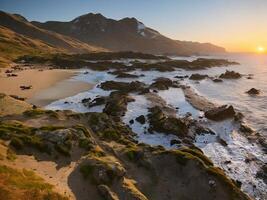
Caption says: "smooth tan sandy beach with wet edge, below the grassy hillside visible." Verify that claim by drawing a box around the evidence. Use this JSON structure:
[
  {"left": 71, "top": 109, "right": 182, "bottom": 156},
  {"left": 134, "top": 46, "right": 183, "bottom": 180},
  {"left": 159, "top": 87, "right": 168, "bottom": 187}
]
[{"left": 0, "top": 69, "right": 92, "bottom": 107}]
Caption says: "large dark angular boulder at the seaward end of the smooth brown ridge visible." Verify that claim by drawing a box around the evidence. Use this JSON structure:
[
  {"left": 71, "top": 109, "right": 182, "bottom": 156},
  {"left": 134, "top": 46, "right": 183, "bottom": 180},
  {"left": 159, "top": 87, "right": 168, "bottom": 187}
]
[{"left": 205, "top": 105, "right": 235, "bottom": 121}]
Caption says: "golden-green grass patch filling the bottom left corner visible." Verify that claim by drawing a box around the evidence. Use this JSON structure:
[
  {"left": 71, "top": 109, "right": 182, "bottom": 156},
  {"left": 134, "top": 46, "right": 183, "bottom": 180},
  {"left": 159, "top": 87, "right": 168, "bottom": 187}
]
[{"left": 0, "top": 165, "right": 68, "bottom": 200}]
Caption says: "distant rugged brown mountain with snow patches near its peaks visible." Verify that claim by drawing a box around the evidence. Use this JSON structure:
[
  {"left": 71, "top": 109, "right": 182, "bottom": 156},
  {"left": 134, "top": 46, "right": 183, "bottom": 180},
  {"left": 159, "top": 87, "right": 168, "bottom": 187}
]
[{"left": 32, "top": 13, "right": 225, "bottom": 55}]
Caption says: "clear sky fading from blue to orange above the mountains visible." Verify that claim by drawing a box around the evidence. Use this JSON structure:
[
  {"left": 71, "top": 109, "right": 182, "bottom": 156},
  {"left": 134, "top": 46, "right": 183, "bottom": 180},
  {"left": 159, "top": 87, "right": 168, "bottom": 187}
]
[{"left": 0, "top": 0, "right": 267, "bottom": 52}]
